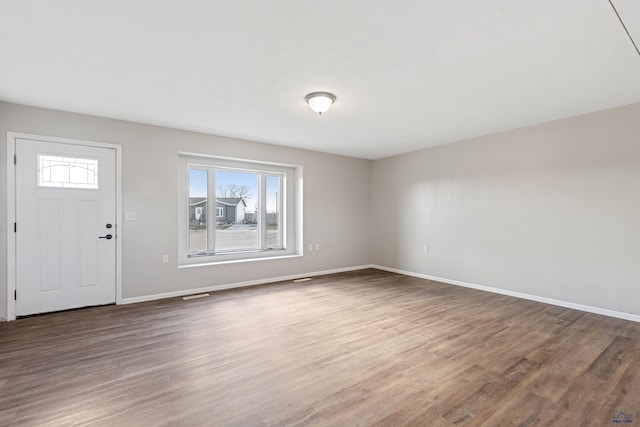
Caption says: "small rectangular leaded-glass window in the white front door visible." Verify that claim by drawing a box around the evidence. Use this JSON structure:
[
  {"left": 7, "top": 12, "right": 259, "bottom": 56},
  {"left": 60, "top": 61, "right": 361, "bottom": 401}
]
[{"left": 38, "top": 154, "right": 98, "bottom": 189}]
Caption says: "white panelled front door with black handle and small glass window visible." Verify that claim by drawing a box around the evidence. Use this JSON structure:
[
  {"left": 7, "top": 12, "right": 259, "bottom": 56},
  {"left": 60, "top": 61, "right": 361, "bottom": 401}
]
[{"left": 15, "top": 138, "right": 116, "bottom": 316}]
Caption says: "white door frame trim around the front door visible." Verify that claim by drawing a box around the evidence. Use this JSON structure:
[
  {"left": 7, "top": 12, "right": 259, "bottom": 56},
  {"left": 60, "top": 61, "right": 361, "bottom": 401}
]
[{"left": 6, "top": 131, "right": 123, "bottom": 321}]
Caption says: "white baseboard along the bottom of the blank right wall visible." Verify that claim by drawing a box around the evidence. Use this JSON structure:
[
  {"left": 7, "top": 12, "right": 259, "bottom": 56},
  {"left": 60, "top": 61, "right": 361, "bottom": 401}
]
[{"left": 371, "top": 265, "right": 640, "bottom": 322}]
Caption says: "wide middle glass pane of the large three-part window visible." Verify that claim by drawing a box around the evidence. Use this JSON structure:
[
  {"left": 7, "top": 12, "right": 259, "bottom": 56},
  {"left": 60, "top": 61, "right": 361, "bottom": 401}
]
[{"left": 215, "top": 170, "right": 255, "bottom": 252}]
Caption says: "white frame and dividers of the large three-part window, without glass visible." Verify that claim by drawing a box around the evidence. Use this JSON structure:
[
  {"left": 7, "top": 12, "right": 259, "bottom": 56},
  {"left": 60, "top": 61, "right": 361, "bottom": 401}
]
[{"left": 178, "top": 152, "right": 303, "bottom": 268}]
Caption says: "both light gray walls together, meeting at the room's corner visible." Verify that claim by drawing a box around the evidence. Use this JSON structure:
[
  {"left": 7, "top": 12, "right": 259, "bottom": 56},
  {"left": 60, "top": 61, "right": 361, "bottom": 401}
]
[{"left": 5, "top": 103, "right": 640, "bottom": 316}]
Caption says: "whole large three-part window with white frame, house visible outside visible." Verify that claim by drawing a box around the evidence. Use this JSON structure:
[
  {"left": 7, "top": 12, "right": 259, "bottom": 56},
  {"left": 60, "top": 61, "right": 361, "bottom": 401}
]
[{"left": 179, "top": 154, "right": 302, "bottom": 265}]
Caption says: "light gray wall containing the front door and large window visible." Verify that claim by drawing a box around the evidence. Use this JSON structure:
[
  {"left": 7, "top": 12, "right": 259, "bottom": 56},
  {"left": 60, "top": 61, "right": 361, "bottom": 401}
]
[{"left": 0, "top": 103, "right": 371, "bottom": 317}]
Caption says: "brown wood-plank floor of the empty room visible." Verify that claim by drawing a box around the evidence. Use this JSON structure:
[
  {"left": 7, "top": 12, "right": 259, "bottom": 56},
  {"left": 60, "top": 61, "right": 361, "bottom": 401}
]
[{"left": 0, "top": 270, "right": 640, "bottom": 426}]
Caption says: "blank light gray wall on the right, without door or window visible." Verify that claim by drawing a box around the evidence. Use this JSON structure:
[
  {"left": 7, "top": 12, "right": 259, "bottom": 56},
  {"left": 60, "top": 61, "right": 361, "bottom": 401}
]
[{"left": 371, "top": 104, "right": 640, "bottom": 314}]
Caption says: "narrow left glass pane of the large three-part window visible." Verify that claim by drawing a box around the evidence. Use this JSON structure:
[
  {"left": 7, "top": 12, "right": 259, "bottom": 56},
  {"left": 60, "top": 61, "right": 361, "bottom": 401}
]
[{"left": 189, "top": 168, "right": 207, "bottom": 254}]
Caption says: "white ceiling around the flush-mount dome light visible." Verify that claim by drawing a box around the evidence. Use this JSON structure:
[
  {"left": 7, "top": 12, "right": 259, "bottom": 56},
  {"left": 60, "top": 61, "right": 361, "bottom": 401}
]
[{"left": 0, "top": 0, "right": 640, "bottom": 159}]
